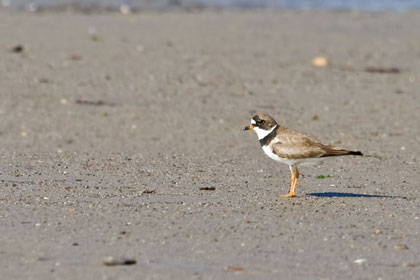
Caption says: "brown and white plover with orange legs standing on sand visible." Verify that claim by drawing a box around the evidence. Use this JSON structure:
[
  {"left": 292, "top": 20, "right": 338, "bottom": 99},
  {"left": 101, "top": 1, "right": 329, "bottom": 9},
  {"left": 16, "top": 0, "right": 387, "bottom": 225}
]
[{"left": 244, "top": 114, "right": 363, "bottom": 197}]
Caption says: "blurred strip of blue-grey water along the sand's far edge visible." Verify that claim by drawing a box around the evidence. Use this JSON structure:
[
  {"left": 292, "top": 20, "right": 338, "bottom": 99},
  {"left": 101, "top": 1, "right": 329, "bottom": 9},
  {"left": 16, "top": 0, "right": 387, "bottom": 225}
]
[{"left": 0, "top": 0, "right": 420, "bottom": 12}]
